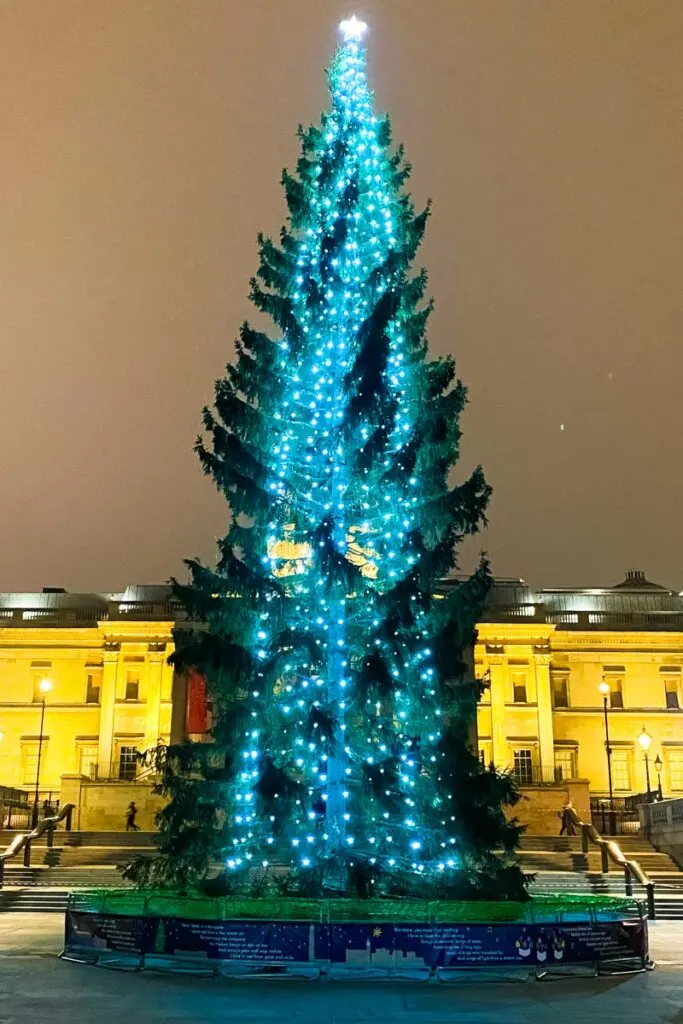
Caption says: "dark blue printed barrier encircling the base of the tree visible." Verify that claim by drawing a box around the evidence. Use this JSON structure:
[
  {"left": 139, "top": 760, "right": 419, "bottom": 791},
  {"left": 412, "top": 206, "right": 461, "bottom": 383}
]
[{"left": 62, "top": 891, "right": 649, "bottom": 978}]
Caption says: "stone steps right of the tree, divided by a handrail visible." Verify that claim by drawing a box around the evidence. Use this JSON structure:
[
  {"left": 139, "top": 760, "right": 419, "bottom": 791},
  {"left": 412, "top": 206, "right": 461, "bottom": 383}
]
[{"left": 519, "top": 836, "right": 683, "bottom": 921}]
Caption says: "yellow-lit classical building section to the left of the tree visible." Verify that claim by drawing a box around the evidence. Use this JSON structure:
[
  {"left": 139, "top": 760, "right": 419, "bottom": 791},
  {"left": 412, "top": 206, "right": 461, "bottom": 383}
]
[{"left": 0, "top": 587, "right": 174, "bottom": 798}]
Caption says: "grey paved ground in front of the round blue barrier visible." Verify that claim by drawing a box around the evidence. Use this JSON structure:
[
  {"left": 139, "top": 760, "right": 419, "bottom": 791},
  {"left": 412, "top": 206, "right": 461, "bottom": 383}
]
[{"left": 0, "top": 913, "right": 683, "bottom": 1024}]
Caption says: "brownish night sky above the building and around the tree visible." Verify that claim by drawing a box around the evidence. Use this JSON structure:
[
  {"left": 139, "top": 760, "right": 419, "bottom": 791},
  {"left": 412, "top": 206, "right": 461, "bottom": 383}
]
[{"left": 0, "top": 0, "right": 683, "bottom": 590}]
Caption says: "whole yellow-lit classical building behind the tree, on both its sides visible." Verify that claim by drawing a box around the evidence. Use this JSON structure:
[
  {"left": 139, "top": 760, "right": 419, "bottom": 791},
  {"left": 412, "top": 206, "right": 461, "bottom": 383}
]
[{"left": 0, "top": 573, "right": 683, "bottom": 798}]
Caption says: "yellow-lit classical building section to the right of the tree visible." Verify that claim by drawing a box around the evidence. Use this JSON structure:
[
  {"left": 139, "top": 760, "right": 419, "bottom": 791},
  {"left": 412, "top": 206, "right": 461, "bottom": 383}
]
[{"left": 475, "top": 572, "right": 683, "bottom": 798}]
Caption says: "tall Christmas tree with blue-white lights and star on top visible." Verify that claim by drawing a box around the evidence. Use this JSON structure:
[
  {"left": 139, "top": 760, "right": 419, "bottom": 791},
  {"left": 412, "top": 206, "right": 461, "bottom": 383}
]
[{"left": 130, "top": 18, "right": 525, "bottom": 898}]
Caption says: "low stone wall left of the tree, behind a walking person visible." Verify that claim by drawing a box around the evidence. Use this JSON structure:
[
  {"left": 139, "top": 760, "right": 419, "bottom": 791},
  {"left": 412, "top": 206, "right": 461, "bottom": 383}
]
[{"left": 60, "top": 775, "right": 164, "bottom": 831}]
